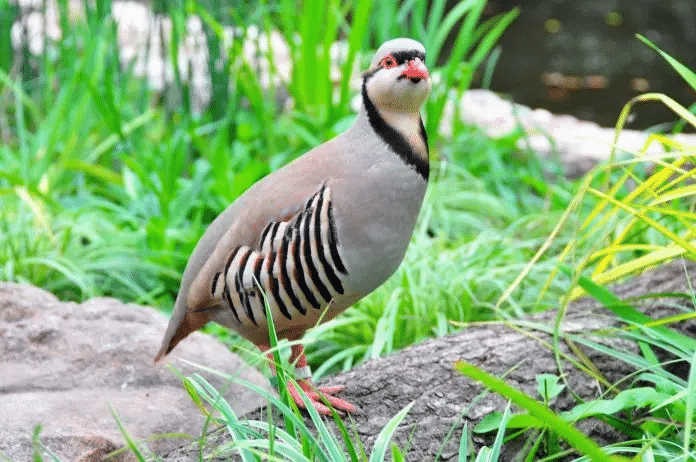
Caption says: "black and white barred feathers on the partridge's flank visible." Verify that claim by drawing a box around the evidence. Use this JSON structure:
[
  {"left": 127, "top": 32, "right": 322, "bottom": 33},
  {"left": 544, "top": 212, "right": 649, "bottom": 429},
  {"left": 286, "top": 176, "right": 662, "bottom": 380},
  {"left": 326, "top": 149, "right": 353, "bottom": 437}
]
[{"left": 210, "top": 185, "right": 348, "bottom": 325}]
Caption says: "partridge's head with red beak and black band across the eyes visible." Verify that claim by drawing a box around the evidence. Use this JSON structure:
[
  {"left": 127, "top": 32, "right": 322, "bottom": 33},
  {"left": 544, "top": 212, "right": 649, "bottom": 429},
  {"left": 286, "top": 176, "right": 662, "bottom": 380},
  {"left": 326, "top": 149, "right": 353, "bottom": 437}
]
[{"left": 363, "top": 38, "right": 432, "bottom": 112}]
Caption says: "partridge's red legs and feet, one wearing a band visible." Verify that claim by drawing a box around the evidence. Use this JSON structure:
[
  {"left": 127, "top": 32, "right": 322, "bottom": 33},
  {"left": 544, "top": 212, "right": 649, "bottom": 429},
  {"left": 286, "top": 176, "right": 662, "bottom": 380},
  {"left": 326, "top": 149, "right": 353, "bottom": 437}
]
[{"left": 258, "top": 344, "right": 355, "bottom": 416}]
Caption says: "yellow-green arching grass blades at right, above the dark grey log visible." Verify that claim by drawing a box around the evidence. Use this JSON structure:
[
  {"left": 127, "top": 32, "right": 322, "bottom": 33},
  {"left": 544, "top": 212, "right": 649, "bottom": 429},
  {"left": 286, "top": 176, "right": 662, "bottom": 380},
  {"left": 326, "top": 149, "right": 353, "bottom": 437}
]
[{"left": 500, "top": 36, "right": 696, "bottom": 308}]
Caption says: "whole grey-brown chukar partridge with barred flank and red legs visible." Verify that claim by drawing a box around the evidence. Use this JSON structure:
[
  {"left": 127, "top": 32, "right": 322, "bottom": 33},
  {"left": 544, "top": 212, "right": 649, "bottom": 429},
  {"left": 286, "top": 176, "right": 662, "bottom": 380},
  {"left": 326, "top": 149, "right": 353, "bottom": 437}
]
[{"left": 155, "top": 38, "right": 432, "bottom": 414}]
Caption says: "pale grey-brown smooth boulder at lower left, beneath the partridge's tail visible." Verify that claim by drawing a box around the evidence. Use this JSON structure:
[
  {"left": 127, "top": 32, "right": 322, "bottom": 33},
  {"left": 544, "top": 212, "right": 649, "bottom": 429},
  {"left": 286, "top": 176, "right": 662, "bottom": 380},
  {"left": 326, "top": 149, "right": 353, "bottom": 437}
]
[{"left": 0, "top": 283, "right": 268, "bottom": 461}]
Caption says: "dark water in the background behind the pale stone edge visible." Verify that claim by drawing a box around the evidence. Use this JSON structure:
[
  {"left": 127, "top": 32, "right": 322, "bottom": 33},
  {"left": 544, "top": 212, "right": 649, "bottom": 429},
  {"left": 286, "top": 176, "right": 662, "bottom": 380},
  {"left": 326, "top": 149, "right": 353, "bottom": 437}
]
[{"left": 478, "top": 0, "right": 696, "bottom": 129}]
